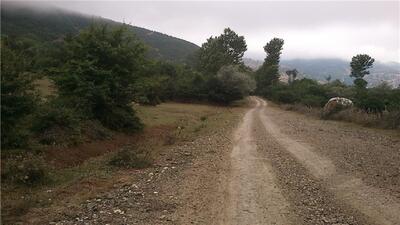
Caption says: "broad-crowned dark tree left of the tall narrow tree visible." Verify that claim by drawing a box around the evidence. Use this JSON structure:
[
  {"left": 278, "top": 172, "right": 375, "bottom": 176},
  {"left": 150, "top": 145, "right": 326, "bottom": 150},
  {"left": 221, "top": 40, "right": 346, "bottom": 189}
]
[{"left": 198, "top": 28, "right": 247, "bottom": 75}]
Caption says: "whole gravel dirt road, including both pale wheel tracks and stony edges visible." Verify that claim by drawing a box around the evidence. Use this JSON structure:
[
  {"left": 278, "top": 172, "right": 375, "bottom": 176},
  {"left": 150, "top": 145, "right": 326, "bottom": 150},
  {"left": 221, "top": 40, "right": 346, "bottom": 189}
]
[{"left": 32, "top": 97, "right": 400, "bottom": 225}]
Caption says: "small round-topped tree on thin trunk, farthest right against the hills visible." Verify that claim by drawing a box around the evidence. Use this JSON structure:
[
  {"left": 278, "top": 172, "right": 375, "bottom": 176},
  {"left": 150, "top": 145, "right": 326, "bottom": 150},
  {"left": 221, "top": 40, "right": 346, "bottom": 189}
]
[{"left": 350, "top": 54, "right": 375, "bottom": 88}]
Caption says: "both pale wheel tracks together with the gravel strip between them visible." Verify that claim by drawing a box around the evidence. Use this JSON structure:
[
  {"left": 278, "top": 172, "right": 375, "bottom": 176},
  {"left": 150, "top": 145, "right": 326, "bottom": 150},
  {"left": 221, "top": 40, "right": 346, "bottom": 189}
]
[{"left": 225, "top": 97, "right": 400, "bottom": 225}]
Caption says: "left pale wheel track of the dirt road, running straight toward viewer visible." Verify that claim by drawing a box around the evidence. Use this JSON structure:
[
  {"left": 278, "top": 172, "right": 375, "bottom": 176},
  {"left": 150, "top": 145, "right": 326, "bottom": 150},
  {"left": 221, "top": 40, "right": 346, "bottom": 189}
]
[{"left": 221, "top": 98, "right": 289, "bottom": 225}]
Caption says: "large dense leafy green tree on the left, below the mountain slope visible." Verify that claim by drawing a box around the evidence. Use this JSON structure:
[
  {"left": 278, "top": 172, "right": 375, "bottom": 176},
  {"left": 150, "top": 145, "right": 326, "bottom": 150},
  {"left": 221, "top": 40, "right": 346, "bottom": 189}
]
[{"left": 53, "top": 25, "right": 145, "bottom": 131}]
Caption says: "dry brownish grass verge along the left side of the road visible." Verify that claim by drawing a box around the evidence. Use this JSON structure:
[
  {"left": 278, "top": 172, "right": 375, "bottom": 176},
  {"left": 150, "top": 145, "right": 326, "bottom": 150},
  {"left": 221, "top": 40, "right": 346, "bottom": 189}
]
[{"left": 1, "top": 102, "right": 246, "bottom": 224}]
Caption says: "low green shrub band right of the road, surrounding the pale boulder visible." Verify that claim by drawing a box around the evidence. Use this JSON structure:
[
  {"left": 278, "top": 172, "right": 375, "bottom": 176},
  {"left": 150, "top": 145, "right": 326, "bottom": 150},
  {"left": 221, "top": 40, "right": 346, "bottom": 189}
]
[{"left": 259, "top": 79, "right": 400, "bottom": 129}]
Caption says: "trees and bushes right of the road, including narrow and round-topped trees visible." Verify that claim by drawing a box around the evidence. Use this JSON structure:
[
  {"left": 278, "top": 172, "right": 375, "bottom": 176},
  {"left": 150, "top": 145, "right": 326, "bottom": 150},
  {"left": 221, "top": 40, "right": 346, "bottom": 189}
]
[{"left": 255, "top": 38, "right": 400, "bottom": 128}]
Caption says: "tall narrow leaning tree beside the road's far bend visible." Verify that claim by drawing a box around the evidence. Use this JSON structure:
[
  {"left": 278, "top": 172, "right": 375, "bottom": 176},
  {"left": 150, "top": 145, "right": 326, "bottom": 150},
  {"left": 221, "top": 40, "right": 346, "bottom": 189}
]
[{"left": 256, "top": 38, "right": 284, "bottom": 92}]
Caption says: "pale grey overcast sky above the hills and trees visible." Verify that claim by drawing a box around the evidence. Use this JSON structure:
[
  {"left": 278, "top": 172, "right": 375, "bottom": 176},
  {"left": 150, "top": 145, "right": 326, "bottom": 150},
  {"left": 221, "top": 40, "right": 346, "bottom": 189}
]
[{"left": 7, "top": 1, "right": 400, "bottom": 62}]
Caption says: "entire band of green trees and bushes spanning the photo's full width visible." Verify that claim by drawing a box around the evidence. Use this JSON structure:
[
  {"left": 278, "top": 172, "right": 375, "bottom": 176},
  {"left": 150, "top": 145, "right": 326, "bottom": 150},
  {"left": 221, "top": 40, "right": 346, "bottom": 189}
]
[{"left": 1, "top": 22, "right": 400, "bottom": 148}]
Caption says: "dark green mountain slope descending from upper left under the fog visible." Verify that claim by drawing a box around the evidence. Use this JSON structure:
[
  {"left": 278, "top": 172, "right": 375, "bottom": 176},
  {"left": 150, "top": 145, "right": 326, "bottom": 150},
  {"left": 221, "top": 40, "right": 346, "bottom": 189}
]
[{"left": 1, "top": 3, "right": 199, "bottom": 62}]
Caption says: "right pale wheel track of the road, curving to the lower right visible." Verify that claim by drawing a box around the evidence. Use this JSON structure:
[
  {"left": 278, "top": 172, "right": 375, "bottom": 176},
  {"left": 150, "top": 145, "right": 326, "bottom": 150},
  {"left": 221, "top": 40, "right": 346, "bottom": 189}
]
[{"left": 256, "top": 96, "right": 400, "bottom": 225}]
